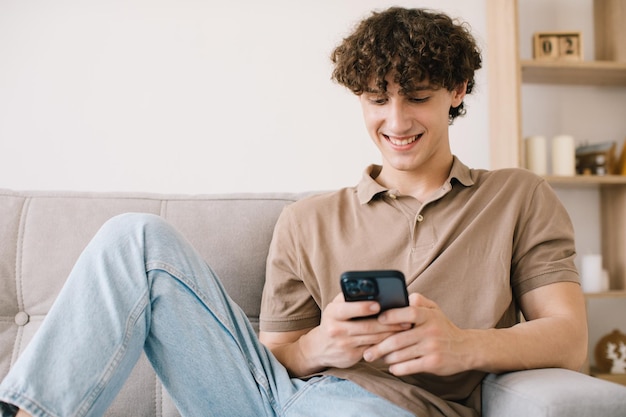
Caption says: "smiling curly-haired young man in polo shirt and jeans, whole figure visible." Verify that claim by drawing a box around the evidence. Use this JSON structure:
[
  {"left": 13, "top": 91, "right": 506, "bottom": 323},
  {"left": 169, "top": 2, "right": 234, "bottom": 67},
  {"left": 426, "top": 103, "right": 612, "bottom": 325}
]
[{"left": 0, "top": 8, "right": 586, "bottom": 417}]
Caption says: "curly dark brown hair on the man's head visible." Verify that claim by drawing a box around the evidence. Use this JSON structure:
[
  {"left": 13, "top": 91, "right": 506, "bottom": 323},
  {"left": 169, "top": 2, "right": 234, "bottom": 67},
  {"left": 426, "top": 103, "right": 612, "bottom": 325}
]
[{"left": 331, "top": 7, "right": 481, "bottom": 121}]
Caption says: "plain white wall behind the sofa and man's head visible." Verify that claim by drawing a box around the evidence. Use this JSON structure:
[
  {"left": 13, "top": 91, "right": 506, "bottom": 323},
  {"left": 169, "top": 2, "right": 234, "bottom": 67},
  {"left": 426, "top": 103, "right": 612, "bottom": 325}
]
[{"left": 0, "top": 0, "right": 489, "bottom": 193}]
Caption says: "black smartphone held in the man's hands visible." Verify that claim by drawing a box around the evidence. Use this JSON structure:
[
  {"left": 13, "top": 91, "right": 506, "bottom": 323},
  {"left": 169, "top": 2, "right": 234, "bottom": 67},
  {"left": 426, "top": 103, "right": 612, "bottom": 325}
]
[{"left": 341, "top": 269, "right": 409, "bottom": 312}]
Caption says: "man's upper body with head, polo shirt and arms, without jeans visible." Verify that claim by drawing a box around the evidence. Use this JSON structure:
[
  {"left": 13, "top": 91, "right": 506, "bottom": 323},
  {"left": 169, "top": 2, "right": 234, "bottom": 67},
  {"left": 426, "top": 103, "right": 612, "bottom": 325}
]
[{"left": 255, "top": 9, "right": 586, "bottom": 415}]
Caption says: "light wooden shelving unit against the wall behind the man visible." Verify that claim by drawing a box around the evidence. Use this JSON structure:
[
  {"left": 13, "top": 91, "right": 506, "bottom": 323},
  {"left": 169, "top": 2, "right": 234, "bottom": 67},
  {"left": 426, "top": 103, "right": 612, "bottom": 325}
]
[{"left": 487, "top": 0, "right": 626, "bottom": 291}]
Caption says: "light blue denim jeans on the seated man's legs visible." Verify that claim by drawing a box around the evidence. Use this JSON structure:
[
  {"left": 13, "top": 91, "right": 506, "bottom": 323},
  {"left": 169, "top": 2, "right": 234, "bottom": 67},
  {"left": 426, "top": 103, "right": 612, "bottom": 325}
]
[{"left": 0, "top": 214, "right": 412, "bottom": 417}]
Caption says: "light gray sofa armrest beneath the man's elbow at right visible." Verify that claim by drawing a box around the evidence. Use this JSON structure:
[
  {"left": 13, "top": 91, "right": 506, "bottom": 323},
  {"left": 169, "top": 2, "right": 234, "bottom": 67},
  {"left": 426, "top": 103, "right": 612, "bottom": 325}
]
[{"left": 482, "top": 369, "right": 626, "bottom": 417}]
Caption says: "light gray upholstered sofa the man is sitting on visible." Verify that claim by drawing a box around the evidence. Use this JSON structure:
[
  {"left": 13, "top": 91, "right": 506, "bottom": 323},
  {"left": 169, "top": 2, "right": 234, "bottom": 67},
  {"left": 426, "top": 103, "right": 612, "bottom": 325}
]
[{"left": 0, "top": 190, "right": 626, "bottom": 417}]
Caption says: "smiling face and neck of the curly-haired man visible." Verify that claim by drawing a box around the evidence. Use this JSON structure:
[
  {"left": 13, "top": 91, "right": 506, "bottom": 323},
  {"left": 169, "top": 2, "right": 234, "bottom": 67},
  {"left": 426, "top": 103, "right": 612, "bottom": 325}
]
[{"left": 359, "top": 77, "right": 465, "bottom": 185}]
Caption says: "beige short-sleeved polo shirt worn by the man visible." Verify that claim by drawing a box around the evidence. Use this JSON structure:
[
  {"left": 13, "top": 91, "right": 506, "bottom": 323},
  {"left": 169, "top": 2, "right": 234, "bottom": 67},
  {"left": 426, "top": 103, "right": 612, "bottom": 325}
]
[{"left": 260, "top": 158, "right": 578, "bottom": 416}]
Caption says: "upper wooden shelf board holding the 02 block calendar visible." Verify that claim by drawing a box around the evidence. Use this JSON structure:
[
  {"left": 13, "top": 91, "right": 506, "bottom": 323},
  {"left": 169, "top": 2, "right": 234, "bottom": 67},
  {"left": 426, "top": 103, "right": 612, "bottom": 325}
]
[{"left": 521, "top": 60, "right": 626, "bottom": 86}]
